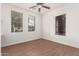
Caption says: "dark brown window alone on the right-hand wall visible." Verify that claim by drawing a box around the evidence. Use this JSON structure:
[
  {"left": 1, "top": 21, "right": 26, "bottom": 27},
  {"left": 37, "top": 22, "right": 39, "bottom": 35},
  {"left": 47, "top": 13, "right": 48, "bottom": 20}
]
[{"left": 55, "top": 14, "right": 66, "bottom": 35}]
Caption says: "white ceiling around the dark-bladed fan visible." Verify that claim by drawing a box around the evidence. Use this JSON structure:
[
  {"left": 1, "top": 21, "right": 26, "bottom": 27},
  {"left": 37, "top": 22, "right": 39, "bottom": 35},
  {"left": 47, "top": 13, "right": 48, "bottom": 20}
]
[{"left": 11, "top": 3, "right": 63, "bottom": 14}]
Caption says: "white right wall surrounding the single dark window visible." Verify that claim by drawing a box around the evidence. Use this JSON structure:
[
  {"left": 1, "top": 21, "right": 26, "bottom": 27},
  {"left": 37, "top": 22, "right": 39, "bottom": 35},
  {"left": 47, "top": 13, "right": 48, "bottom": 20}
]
[{"left": 43, "top": 4, "right": 79, "bottom": 48}]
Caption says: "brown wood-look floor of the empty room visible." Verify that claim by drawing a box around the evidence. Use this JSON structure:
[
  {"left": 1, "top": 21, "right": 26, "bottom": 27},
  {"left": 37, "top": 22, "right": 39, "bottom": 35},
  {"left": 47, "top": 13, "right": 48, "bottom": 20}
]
[{"left": 1, "top": 39, "right": 79, "bottom": 56}]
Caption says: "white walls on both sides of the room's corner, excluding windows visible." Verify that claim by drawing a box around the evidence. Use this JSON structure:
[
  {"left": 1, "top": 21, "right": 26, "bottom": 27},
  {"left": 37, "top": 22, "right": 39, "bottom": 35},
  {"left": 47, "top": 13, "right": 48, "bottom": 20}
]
[{"left": 1, "top": 4, "right": 79, "bottom": 48}]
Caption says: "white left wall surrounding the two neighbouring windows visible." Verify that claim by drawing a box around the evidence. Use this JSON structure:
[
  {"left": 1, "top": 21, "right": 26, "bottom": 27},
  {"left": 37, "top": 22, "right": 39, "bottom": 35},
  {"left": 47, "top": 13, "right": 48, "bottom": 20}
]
[{"left": 1, "top": 4, "right": 41, "bottom": 47}]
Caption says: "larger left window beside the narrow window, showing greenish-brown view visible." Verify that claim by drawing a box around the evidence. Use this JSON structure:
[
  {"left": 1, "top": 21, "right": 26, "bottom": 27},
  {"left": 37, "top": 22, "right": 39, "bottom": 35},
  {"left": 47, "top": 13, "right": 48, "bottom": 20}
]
[{"left": 11, "top": 11, "right": 23, "bottom": 32}]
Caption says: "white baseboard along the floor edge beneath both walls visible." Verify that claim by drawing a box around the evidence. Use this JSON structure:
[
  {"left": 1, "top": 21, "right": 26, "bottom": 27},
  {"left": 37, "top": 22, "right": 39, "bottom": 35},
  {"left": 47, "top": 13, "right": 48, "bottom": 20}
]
[{"left": 1, "top": 37, "right": 79, "bottom": 48}]
